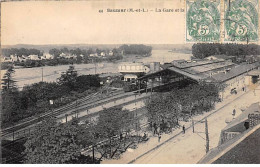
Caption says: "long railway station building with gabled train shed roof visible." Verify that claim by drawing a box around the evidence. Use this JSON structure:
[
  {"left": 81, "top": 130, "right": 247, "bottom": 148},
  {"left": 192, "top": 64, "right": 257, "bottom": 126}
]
[{"left": 137, "top": 59, "right": 259, "bottom": 100}]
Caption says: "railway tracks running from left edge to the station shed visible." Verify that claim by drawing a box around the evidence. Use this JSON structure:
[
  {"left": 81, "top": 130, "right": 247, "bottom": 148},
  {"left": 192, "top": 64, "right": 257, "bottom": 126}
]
[{"left": 1, "top": 78, "right": 176, "bottom": 140}]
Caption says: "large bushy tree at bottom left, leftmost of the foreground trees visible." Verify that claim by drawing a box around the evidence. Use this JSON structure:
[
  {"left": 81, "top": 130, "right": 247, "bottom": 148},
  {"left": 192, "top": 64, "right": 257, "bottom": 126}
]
[{"left": 24, "top": 118, "right": 90, "bottom": 164}]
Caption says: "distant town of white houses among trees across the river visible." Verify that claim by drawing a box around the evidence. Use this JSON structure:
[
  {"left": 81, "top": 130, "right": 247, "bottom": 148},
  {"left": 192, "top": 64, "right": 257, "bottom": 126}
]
[{"left": 1, "top": 45, "right": 152, "bottom": 69}]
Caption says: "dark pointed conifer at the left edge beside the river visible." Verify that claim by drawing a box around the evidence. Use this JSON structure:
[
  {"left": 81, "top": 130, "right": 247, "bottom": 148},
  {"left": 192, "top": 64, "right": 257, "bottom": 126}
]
[{"left": 2, "top": 66, "right": 15, "bottom": 90}]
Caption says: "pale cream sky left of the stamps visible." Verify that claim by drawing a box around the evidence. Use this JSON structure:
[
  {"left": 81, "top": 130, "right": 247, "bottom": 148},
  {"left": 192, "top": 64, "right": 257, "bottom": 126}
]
[{"left": 1, "top": 0, "right": 185, "bottom": 45}]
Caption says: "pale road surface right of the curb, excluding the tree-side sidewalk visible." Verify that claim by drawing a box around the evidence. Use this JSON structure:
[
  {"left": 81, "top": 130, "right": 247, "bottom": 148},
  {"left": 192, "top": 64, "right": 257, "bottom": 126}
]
[{"left": 134, "top": 87, "right": 260, "bottom": 164}]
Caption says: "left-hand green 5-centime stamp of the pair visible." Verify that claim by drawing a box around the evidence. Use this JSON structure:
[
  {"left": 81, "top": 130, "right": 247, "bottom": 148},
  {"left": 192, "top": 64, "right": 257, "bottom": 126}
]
[{"left": 186, "top": 0, "right": 220, "bottom": 42}]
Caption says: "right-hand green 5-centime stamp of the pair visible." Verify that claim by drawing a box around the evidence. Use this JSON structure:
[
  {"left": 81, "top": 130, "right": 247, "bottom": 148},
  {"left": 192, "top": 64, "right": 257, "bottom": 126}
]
[{"left": 224, "top": 0, "right": 259, "bottom": 42}]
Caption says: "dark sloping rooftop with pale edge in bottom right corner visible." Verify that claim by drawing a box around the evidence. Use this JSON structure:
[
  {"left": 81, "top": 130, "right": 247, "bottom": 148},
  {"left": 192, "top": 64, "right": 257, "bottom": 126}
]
[{"left": 198, "top": 124, "right": 260, "bottom": 164}]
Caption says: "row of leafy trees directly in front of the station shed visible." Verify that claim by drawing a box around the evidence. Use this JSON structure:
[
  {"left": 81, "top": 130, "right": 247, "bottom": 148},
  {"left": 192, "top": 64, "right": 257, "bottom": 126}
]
[{"left": 146, "top": 83, "right": 221, "bottom": 131}]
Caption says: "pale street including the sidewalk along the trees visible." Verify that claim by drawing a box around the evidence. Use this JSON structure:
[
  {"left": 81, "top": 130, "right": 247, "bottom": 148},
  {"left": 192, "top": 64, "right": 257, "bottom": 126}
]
[{"left": 102, "top": 87, "right": 260, "bottom": 164}]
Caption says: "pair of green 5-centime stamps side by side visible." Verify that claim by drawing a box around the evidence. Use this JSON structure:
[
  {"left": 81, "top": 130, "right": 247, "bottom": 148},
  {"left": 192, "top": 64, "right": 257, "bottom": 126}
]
[{"left": 186, "top": 0, "right": 259, "bottom": 43}]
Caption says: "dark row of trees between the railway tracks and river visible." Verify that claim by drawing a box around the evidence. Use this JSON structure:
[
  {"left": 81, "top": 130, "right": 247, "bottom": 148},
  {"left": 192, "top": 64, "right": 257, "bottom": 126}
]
[{"left": 2, "top": 66, "right": 100, "bottom": 126}]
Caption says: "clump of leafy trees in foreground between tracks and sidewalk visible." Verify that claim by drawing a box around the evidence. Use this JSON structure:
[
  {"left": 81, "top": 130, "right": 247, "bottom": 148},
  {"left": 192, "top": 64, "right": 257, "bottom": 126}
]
[{"left": 24, "top": 107, "right": 137, "bottom": 164}]
